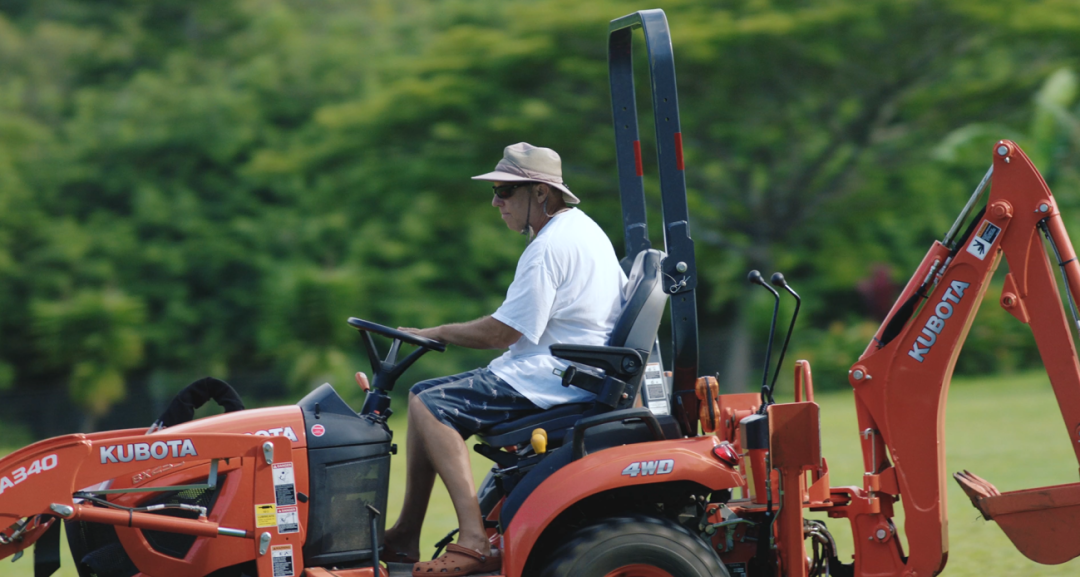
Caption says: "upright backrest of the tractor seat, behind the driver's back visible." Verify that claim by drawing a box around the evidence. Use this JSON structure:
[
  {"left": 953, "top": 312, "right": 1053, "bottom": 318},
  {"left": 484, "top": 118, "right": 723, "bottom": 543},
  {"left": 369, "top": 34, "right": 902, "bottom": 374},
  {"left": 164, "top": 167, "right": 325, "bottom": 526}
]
[{"left": 607, "top": 249, "right": 667, "bottom": 354}]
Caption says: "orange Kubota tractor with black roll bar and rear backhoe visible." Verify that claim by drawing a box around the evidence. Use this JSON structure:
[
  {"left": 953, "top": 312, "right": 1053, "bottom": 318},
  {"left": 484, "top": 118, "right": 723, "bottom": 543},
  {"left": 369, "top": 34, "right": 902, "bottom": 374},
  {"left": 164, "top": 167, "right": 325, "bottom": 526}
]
[{"left": 0, "top": 10, "right": 1080, "bottom": 577}]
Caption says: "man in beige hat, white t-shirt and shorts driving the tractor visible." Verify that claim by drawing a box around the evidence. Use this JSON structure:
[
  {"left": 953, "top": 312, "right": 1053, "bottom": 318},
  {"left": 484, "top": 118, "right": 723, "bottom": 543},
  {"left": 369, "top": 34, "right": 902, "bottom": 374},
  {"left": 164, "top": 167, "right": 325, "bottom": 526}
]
[{"left": 383, "top": 143, "right": 626, "bottom": 575}]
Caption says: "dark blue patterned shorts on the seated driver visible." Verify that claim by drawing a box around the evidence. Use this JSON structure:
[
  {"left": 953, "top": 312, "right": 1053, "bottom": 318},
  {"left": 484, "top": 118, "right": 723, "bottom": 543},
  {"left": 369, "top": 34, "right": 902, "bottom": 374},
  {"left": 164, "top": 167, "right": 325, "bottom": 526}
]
[{"left": 409, "top": 368, "right": 543, "bottom": 439}]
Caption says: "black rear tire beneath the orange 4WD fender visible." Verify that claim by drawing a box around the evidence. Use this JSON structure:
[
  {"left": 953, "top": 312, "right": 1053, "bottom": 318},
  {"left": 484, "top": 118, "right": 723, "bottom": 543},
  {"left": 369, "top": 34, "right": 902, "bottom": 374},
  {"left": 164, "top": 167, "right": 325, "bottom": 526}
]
[{"left": 540, "top": 515, "right": 730, "bottom": 577}]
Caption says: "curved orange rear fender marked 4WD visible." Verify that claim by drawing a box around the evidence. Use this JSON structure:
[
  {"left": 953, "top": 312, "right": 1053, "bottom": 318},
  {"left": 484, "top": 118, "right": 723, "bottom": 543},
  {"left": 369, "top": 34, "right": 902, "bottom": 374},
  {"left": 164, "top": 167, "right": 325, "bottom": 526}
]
[{"left": 502, "top": 435, "right": 744, "bottom": 577}]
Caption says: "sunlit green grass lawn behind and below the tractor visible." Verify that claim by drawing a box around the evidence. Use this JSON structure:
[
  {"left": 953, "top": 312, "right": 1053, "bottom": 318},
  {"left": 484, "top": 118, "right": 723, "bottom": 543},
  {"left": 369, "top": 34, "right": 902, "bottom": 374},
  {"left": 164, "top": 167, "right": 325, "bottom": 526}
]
[{"left": 6, "top": 374, "right": 1080, "bottom": 577}]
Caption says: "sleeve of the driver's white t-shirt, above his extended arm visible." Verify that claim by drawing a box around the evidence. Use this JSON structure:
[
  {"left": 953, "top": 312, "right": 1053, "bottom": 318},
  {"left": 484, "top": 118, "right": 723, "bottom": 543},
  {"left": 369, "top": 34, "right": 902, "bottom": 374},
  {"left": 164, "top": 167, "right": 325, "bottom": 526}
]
[{"left": 491, "top": 258, "right": 557, "bottom": 345}]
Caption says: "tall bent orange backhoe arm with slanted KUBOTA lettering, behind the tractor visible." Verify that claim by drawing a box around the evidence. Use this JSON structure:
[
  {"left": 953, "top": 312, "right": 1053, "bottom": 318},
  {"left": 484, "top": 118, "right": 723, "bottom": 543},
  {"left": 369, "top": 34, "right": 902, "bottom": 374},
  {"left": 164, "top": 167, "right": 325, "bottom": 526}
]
[{"left": 849, "top": 140, "right": 1080, "bottom": 577}]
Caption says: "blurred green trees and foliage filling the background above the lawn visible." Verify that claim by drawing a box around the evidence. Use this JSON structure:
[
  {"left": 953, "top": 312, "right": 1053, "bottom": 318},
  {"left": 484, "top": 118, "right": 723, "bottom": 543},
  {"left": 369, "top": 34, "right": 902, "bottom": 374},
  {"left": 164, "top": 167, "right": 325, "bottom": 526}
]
[{"left": 0, "top": 0, "right": 1080, "bottom": 434}]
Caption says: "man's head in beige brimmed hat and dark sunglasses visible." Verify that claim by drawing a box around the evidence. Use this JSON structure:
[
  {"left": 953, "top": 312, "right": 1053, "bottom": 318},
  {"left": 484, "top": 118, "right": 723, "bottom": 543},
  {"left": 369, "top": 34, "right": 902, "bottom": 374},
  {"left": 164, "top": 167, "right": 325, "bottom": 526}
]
[{"left": 473, "top": 143, "right": 581, "bottom": 233}]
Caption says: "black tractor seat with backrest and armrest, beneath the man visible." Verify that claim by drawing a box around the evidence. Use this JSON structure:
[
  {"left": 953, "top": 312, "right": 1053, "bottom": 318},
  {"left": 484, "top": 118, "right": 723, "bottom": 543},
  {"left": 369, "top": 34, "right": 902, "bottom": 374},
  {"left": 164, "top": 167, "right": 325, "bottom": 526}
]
[{"left": 477, "top": 249, "right": 669, "bottom": 456}]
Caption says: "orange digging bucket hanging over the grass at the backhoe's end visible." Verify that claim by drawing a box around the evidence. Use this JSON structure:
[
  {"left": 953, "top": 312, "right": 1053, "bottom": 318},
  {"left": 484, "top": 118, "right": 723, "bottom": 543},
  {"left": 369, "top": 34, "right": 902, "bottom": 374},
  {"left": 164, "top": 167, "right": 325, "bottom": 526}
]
[{"left": 953, "top": 471, "right": 1080, "bottom": 565}]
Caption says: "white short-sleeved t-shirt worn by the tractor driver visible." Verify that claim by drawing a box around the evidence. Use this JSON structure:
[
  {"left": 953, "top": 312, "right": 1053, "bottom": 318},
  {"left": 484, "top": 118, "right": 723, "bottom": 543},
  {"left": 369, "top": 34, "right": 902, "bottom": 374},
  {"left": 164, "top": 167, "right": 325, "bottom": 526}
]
[{"left": 488, "top": 209, "right": 626, "bottom": 408}]
